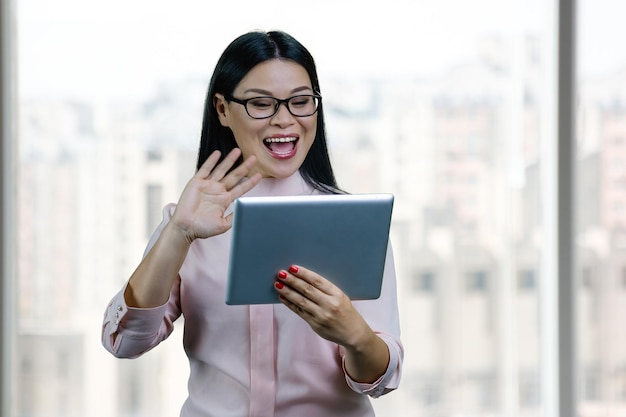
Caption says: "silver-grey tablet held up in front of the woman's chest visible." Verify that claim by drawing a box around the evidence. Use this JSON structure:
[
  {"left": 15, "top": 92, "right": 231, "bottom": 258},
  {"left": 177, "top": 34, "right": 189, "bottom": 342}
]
[{"left": 226, "top": 194, "right": 394, "bottom": 305}]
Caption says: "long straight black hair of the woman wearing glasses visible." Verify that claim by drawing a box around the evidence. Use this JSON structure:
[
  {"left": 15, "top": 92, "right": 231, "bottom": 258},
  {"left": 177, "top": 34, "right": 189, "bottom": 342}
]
[{"left": 197, "top": 31, "right": 340, "bottom": 193}]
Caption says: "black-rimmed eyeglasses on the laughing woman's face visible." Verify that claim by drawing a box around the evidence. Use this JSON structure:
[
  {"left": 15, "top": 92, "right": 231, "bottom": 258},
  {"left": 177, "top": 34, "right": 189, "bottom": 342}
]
[{"left": 224, "top": 94, "right": 322, "bottom": 119}]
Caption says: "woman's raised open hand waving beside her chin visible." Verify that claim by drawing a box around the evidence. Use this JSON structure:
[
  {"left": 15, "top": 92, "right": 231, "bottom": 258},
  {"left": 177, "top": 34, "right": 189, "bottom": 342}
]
[{"left": 171, "top": 148, "right": 261, "bottom": 243}]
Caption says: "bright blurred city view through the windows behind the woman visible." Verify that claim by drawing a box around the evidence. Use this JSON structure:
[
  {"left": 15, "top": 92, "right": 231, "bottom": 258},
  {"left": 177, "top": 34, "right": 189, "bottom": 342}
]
[{"left": 2, "top": 0, "right": 626, "bottom": 417}]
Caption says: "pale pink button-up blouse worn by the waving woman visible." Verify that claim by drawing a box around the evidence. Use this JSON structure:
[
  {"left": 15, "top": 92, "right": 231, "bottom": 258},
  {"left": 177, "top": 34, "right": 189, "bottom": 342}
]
[{"left": 102, "top": 173, "right": 403, "bottom": 417}]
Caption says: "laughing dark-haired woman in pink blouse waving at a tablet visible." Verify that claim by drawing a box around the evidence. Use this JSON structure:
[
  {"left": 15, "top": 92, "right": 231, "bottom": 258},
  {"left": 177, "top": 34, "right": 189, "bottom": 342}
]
[{"left": 102, "top": 32, "right": 403, "bottom": 417}]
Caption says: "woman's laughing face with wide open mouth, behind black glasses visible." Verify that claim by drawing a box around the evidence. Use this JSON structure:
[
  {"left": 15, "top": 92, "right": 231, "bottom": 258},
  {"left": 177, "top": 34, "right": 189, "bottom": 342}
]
[{"left": 214, "top": 59, "right": 317, "bottom": 178}]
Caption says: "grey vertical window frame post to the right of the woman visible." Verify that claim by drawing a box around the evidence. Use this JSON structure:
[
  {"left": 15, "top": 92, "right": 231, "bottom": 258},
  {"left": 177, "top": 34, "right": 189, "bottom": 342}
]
[{"left": 542, "top": 0, "right": 579, "bottom": 416}]
